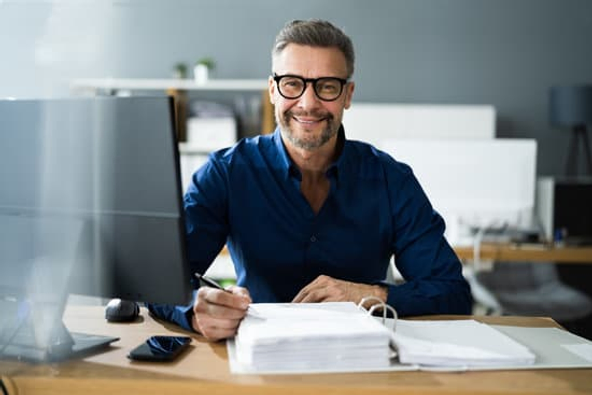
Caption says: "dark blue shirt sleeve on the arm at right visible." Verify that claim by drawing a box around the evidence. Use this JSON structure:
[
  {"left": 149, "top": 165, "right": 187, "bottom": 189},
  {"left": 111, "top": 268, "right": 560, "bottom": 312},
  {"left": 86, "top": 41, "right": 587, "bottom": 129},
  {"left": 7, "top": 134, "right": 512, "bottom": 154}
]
[{"left": 387, "top": 163, "right": 472, "bottom": 316}]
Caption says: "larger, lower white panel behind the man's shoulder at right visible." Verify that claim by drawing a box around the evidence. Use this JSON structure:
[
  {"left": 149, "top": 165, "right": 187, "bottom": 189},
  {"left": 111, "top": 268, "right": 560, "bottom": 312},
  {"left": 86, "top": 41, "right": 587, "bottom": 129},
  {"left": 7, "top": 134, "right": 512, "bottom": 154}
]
[{"left": 379, "top": 139, "right": 537, "bottom": 245}]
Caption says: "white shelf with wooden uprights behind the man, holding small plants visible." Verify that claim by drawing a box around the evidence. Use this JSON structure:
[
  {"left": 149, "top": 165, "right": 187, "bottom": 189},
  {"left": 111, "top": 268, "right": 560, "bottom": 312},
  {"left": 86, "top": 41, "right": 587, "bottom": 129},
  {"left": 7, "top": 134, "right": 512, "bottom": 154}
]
[{"left": 70, "top": 78, "right": 275, "bottom": 141}]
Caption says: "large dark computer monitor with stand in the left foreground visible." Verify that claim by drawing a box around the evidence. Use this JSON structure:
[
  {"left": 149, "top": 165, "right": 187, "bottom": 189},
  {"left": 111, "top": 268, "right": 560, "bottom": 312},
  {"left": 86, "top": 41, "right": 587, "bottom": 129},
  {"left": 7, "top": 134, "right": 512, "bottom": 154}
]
[{"left": 0, "top": 97, "right": 191, "bottom": 360}]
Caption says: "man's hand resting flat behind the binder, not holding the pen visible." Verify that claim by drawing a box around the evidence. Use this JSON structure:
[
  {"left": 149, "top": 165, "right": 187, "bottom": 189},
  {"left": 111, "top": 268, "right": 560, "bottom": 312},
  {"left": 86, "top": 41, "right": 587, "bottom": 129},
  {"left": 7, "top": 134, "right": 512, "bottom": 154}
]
[{"left": 292, "top": 275, "right": 388, "bottom": 308}]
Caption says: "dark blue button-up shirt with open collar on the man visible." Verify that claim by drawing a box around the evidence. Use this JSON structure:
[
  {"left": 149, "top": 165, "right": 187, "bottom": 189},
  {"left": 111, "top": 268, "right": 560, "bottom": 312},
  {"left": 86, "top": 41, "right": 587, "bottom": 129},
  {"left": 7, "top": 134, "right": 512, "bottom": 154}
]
[{"left": 151, "top": 129, "right": 472, "bottom": 328}]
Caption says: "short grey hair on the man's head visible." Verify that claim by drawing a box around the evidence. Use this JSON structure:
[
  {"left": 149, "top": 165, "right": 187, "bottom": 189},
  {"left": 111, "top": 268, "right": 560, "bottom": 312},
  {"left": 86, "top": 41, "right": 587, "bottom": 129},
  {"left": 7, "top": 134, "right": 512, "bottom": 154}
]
[{"left": 271, "top": 19, "right": 355, "bottom": 78}]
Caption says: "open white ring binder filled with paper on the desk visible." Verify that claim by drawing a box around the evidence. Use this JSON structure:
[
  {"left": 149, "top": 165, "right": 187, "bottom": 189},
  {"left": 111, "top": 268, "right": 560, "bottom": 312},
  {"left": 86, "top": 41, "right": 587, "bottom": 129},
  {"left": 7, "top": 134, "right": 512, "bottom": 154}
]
[{"left": 227, "top": 304, "right": 592, "bottom": 374}]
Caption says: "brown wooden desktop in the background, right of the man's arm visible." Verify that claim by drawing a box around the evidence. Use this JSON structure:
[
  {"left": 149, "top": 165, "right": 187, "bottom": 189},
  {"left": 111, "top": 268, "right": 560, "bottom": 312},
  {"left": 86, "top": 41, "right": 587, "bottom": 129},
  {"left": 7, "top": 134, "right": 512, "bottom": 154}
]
[{"left": 454, "top": 244, "right": 592, "bottom": 264}]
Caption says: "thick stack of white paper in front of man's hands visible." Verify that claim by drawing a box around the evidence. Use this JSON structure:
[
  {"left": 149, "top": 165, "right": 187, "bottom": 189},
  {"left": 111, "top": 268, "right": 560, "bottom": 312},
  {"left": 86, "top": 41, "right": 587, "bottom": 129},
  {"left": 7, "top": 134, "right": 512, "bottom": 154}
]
[{"left": 235, "top": 303, "right": 391, "bottom": 372}]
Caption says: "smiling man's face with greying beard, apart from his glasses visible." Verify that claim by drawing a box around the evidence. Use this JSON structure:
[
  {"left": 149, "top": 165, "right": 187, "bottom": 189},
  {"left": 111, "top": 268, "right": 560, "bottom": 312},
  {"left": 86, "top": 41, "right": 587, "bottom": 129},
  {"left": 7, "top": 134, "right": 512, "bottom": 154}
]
[{"left": 269, "top": 44, "right": 354, "bottom": 151}]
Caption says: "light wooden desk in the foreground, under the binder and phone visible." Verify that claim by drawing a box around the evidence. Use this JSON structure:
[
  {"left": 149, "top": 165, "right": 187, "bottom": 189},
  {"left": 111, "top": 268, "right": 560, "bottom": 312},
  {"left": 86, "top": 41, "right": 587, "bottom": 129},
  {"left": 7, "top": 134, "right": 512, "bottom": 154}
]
[{"left": 0, "top": 306, "right": 592, "bottom": 395}]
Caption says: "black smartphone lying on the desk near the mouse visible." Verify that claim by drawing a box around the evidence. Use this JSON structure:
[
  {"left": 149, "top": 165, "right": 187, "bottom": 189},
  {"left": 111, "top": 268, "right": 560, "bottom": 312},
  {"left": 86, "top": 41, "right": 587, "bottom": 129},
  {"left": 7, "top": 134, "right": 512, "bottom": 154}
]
[{"left": 127, "top": 336, "right": 191, "bottom": 362}]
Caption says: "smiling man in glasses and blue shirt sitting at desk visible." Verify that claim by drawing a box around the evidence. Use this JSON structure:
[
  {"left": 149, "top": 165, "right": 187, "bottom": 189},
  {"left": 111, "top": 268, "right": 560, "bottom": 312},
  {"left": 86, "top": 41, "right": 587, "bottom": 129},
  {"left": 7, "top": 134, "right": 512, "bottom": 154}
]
[{"left": 152, "top": 20, "right": 471, "bottom": 340}]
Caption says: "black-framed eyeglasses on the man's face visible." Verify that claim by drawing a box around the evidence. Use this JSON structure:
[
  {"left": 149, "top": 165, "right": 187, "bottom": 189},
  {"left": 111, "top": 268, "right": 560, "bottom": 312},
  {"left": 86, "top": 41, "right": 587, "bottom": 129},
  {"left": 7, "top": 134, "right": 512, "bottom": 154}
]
[{"left": 273, "top": 74, "right": 347, "bottom": 101}]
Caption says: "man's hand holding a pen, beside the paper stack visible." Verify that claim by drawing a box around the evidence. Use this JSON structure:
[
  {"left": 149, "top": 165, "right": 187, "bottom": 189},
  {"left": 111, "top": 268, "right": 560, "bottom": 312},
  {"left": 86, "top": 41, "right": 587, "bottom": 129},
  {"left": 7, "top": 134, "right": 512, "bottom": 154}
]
[{"left": 191, "top": 286, "right": 251, "bottom": 341}]
